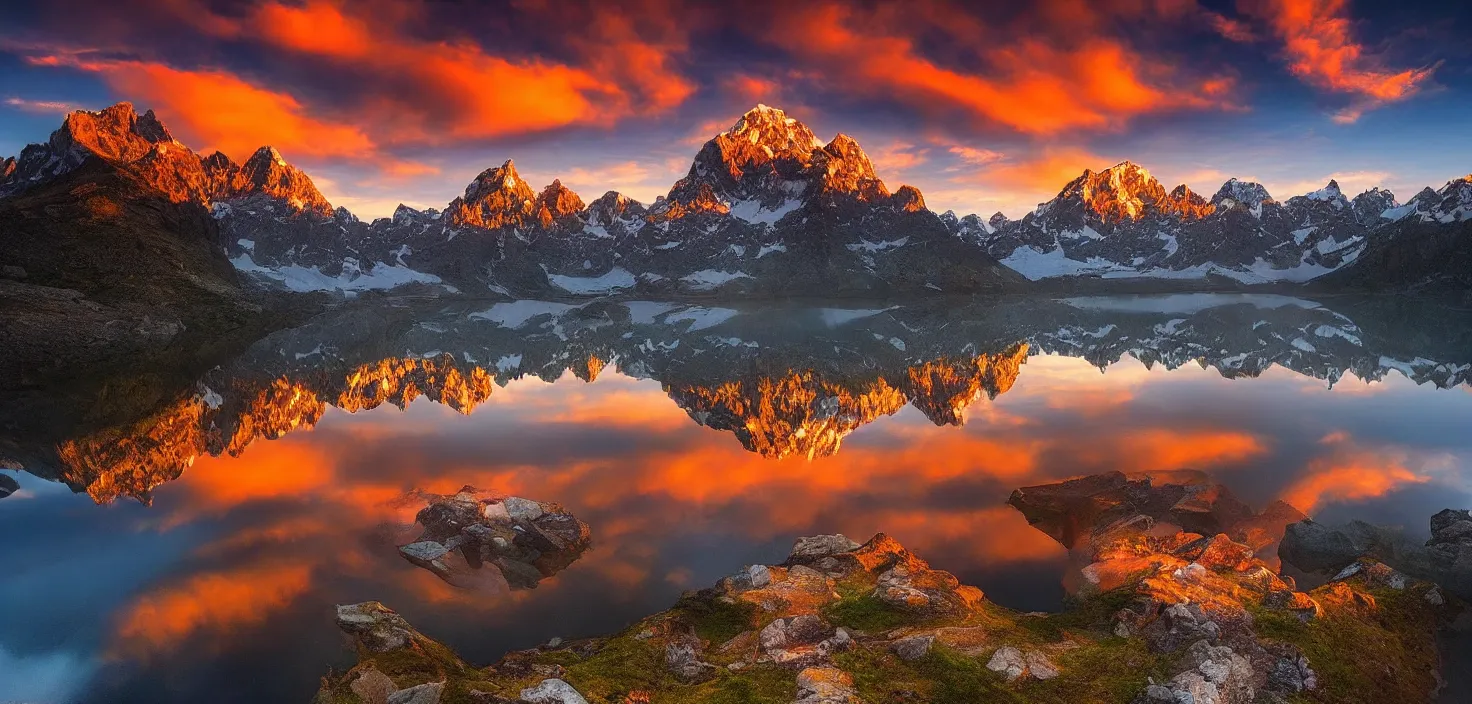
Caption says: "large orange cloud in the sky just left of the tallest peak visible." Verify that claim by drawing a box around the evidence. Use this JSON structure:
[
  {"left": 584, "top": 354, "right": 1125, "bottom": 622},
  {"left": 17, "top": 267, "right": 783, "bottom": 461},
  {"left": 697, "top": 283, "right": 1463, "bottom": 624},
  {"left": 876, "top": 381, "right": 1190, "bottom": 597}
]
[{"left": 213, "top": 0, "right": 683, "bottom": 143}]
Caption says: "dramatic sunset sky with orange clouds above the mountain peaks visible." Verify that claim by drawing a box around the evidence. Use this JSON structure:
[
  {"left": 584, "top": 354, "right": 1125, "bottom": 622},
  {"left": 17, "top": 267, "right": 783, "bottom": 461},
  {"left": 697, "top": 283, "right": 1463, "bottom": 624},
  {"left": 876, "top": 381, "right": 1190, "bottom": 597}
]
[{"left": 0, "top": 0, "right": 1472, "bottom": 217}]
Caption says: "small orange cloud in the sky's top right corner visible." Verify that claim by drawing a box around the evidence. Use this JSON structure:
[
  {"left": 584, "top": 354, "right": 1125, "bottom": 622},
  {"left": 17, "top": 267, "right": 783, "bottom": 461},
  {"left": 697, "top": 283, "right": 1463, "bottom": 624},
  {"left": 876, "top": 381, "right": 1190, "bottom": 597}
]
[{"left": 1241, "top": 0, "right": 1435, "bottom": 122}]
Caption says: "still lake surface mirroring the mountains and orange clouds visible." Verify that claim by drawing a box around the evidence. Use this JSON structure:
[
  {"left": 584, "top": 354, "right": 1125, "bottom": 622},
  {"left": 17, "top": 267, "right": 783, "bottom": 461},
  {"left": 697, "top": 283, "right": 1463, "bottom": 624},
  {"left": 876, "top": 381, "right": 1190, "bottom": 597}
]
[{"left": 0, "top": 295, "right": 1472, "bottom": 701}]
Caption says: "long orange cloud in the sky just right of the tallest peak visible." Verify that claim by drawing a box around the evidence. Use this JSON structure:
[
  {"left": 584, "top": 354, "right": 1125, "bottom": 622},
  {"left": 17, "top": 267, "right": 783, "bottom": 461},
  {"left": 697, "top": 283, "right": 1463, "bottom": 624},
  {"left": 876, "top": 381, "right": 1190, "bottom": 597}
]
[{"left": 768, "top": 3, "right": 1226, "bottom": 134}]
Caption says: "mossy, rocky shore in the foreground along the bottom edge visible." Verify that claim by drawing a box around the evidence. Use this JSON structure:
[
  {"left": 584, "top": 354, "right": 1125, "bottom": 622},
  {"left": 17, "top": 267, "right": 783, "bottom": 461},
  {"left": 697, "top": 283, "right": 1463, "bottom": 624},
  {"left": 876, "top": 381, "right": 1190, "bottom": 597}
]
[{"left": 316, "top": 521, "right": 1454, "bottom": 704}]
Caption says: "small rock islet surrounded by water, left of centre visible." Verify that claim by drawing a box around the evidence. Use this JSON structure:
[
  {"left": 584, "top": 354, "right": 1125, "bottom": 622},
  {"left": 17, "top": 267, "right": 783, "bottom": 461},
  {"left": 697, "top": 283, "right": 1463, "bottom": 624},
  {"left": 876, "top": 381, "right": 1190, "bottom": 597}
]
[{"left": 399, "top": 486, "right": 592, "bottom": 591}]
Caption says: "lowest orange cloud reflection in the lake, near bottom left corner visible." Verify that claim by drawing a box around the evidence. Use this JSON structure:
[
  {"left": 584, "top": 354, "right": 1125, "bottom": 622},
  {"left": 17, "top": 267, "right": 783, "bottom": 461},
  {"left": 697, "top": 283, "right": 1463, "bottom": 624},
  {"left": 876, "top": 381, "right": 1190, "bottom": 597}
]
[{"left": 115, "top": 564, "right": 311, "bottom": 657}]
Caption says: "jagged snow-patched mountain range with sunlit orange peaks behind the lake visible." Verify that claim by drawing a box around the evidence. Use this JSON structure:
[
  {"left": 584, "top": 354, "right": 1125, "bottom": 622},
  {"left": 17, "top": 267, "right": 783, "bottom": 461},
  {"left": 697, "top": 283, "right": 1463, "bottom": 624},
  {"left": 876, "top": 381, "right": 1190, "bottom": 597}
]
[{"left": 0, "top": 103, "right": 1472, "bottom": 296}]
